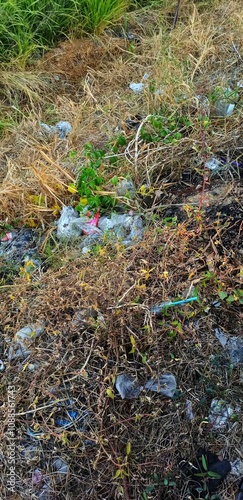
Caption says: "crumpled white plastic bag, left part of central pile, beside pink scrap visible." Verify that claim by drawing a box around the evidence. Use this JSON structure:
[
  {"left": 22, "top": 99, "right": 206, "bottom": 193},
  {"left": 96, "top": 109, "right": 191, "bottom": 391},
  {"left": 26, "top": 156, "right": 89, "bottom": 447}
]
[{"left": 57, "top": 206, "right": 99, "bottom": 240}]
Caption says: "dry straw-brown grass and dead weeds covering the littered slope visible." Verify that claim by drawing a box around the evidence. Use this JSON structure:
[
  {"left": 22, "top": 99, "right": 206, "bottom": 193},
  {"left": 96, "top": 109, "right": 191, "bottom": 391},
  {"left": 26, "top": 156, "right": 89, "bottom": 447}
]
[{"left": 0, "top": 0, "right": 243, "bottom": 500}]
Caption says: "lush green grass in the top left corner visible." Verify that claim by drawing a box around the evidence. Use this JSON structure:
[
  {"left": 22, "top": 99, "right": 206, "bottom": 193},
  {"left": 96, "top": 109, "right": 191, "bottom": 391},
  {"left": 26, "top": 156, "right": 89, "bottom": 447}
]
[{"left": 0, "top": 0, "right": 130, "bottom": 65}]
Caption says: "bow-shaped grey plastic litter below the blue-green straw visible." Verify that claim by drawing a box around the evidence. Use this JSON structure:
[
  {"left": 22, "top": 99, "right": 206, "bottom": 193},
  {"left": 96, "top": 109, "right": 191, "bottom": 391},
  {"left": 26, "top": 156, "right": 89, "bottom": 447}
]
[{"left": 115, "top": 373, "right": 176, "bottom": 399}]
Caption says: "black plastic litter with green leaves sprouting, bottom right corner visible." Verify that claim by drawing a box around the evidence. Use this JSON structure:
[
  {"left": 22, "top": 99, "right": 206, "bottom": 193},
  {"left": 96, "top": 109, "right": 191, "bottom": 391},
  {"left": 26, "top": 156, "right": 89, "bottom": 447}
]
[{"left": 181, "top": 448, "right": 231, "bottom": 499}]
